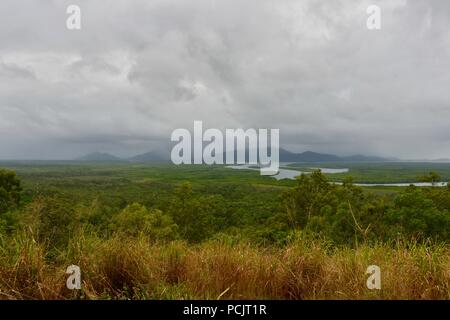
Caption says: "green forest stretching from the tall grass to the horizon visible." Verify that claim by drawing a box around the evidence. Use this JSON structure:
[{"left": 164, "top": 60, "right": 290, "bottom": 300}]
[{"left": 0, "top": 164, "right": 450, "bottom": 249}]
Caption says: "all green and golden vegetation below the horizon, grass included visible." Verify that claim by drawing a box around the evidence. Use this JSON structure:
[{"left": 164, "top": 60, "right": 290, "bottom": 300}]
[{"left": 0, "top": 163, "right": 450, "bottom": 299}]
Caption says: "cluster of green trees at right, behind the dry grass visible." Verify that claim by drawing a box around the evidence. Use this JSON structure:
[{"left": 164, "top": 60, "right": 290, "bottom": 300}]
[{"left": 281, "top": 171, "right": 450, "bottom": 244}]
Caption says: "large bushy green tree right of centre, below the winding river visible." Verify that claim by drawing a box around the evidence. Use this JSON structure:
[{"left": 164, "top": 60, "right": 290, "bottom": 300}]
[{"left": 279, "top": 171, "right": 385, "bottom": 244}]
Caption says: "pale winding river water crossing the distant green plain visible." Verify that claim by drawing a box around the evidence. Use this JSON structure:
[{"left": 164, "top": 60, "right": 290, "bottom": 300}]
[{"left": 227, "top": 164, "right": 447, "bottom": 187}]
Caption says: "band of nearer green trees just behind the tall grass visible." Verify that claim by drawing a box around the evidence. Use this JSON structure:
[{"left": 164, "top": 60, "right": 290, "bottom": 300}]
[{"left": 0, "top": 170, "right": 450, "bottom": 248}]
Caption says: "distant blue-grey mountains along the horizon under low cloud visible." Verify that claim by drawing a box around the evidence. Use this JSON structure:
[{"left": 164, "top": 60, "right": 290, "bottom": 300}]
[{"left": 76, "top": 149, "right": 398, "bottom": 163}]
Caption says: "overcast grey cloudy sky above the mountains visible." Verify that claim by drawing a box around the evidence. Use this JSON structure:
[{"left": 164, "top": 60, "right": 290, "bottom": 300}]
[{"left": 0, "top": 0, "right": 450, "bottom": 159}]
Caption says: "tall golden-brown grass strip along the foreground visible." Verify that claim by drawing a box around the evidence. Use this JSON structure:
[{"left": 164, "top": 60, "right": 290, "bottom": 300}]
[{"left": 0, "top": 232, "right": 450, "bottom": 299}]
